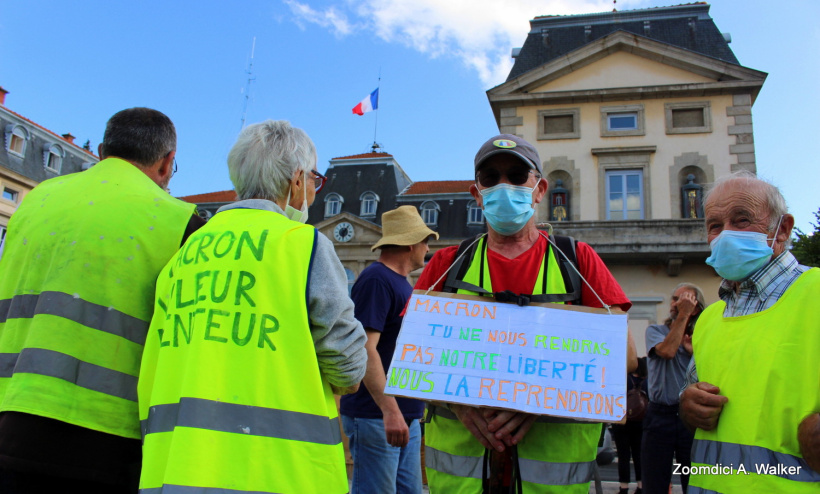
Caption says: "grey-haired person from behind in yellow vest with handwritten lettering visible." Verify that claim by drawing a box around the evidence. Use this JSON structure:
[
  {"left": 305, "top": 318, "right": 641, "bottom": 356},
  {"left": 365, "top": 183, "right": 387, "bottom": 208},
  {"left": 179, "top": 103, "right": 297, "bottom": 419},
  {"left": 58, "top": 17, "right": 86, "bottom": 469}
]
[{"left": 138, "top": 120, "right": 367, "bottom": 494}]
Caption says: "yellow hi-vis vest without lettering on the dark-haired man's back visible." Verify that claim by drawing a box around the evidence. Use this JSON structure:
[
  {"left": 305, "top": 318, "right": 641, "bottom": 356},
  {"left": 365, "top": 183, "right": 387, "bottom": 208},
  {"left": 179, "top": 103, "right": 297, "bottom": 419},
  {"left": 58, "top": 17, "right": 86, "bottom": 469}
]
[{"left": 0, "top": 158, "right": 195, "bottom": 439}]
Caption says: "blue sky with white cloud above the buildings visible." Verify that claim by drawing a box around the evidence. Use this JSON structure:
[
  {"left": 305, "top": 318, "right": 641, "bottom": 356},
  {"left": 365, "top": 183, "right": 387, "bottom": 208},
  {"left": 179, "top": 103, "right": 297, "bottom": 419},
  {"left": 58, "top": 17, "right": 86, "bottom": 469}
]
[{"left": 0, "top": 0, "right": 820, "bottom": 231}]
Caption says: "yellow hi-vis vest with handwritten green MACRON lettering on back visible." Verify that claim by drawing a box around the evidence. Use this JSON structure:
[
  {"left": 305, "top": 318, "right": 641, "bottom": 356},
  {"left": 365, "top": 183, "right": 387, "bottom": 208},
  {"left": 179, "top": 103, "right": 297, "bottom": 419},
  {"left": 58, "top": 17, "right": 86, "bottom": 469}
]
[{"left": 139, "top": 209, "right": 347, "bottom": 494}]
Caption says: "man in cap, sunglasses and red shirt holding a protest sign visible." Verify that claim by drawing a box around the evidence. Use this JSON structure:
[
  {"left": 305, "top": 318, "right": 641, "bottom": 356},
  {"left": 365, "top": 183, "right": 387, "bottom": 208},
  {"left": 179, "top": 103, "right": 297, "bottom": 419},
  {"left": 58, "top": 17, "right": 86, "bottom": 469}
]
[{"left": 416, "top": 134, "right": 637, "bottom": 494}]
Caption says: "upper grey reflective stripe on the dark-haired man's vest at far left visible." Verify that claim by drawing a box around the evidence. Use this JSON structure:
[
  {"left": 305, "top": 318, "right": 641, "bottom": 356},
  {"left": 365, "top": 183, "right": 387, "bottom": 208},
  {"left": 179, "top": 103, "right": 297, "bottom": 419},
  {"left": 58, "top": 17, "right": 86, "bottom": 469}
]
[{"left": 0, "top": 292, "right": 149, "bottom": 345}]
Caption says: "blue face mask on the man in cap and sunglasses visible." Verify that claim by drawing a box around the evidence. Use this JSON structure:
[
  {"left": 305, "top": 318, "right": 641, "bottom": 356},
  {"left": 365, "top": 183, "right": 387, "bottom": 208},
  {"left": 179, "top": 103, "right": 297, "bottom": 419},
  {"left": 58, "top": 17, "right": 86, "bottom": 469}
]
[{"left": 479, "top": 184, "right": 535, "bottom": 235}]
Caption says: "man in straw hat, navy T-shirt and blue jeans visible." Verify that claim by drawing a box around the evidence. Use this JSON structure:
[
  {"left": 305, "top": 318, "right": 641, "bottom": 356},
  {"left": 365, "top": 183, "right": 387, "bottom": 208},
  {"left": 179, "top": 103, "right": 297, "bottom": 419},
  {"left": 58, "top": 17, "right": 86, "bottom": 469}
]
[{"left": 341, "top": 206, "right": 438, "bottom": 494}]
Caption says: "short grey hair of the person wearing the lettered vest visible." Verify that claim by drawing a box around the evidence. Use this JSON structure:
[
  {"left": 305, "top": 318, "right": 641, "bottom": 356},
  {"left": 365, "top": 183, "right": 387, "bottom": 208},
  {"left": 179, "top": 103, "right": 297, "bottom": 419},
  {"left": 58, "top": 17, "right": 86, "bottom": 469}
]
[{"left": 228, "top": 120, "right": 317, "bottom": 202}]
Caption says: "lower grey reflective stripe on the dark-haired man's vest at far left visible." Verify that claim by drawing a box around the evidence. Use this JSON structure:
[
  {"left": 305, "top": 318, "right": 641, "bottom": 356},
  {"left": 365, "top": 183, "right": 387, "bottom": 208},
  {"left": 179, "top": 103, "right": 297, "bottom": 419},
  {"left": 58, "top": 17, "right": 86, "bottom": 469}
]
[{"left": 0, "top": 348, "right": 137, "bottom": 401}]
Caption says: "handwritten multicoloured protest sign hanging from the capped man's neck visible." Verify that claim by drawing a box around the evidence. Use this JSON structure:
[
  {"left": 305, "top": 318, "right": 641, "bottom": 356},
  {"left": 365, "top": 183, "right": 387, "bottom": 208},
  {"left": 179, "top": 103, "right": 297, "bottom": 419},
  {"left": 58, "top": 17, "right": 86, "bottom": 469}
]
[{"left": 385, "top": 290, "right": 627, "bottom": 422}]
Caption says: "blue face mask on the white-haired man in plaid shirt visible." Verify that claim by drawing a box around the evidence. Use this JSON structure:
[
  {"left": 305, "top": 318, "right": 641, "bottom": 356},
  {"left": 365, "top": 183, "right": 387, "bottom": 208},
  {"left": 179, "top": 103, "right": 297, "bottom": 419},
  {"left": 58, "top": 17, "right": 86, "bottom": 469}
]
[{"left": 706, "top": 216, "right": 783, "bottom": 281}]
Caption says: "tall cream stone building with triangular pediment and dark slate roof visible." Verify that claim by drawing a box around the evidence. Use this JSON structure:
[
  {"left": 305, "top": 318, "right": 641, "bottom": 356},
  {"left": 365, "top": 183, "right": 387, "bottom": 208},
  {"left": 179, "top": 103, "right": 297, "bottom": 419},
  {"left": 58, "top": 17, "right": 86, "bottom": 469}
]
[{"left": 487, "top": 2, "right": 766, "bottom": 351}]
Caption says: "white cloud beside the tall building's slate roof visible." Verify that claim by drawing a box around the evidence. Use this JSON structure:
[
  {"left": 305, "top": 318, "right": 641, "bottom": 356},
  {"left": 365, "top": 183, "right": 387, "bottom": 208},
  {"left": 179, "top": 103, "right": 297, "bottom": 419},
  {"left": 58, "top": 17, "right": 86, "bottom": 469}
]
[{"left": 284, "top": 0, "right": 646, "bottom": 87}]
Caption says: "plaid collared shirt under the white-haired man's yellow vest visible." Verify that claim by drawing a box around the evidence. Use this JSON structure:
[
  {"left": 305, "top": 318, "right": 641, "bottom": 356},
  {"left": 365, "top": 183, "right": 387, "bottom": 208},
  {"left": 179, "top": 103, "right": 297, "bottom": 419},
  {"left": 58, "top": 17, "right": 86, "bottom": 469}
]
[{"left": 681, "top": 251, "right": 809, "bottom": 393}]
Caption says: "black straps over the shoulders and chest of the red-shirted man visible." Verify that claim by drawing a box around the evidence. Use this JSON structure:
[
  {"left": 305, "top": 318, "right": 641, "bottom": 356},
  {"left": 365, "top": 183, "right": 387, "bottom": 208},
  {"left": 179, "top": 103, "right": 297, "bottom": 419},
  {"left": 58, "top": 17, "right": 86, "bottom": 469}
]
[{"left": 443, "top": 234, "right": 581, "bottom": 306}]
